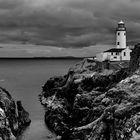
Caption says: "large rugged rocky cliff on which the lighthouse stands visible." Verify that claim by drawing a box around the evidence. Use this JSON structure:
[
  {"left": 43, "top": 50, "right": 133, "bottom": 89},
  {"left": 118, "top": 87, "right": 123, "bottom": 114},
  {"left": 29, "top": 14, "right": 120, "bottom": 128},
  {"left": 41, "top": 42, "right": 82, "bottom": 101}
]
[{"left": 40, "top": 46, "right": 140, "bottom": 140}]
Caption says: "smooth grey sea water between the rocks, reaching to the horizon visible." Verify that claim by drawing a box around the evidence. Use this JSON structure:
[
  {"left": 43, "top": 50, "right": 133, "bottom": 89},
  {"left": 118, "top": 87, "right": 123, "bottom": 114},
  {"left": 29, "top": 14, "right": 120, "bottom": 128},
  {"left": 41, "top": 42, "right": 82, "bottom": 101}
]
[{"left": 0, "top": 59, "right": 80, "bottom": 140}]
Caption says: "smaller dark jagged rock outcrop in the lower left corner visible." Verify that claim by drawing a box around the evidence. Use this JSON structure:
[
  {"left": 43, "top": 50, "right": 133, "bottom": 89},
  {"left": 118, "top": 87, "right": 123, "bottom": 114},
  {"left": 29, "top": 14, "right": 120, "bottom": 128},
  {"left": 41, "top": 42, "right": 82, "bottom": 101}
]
[{"left": 0, "top": 87, "right": 31, "bottom": 140}]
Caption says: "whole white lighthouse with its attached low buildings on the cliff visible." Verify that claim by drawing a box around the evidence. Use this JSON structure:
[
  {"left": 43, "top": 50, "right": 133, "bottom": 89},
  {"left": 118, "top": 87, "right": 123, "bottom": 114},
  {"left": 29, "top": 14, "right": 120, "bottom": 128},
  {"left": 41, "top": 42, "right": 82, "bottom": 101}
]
[{"left": 96, "top": 21, "right": 132, "bottom": 61}]
